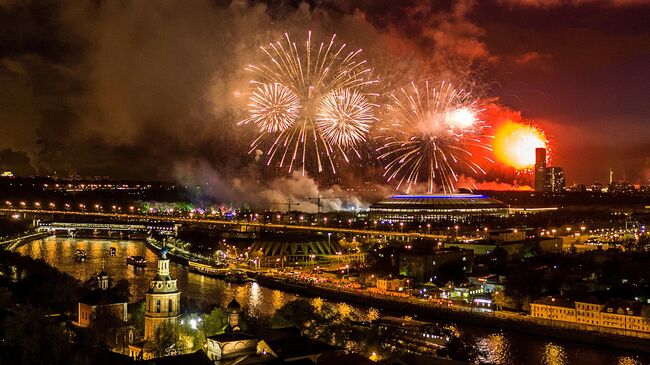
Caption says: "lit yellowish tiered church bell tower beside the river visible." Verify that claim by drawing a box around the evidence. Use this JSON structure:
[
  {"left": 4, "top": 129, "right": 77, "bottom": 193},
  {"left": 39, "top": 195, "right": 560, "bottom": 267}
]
[{"left": 144, "top": 247, "right": 181, "bottom": 340}]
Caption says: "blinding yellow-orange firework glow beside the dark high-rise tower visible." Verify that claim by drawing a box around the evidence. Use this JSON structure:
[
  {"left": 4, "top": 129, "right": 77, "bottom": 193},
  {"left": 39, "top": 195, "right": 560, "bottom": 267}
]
[{"left": 492, "top": 120, "right": 548, "bottom": 170}]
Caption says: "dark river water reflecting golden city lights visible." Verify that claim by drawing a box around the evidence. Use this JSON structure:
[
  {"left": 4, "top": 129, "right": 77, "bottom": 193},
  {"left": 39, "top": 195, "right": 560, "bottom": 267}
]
[{"left": 18, "top": 237, "right": 650, "bottom": 365}]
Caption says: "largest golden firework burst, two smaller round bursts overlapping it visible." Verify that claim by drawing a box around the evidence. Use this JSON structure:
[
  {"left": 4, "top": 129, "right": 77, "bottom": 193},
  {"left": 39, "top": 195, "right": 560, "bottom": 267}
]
[{"left": 239, "top": 32, "right": 377, "bottom": 175}]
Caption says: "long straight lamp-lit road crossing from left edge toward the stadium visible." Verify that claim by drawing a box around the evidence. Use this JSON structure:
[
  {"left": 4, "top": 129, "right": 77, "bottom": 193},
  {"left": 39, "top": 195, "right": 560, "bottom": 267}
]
[{"left": 0, "top": 208, "right": 448, "bottom": 240}]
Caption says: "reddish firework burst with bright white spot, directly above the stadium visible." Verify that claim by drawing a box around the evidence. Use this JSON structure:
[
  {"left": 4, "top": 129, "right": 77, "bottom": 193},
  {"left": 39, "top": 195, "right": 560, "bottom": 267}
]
[{"left": 377, "top": 82, "right": 492, "bottom": 193}]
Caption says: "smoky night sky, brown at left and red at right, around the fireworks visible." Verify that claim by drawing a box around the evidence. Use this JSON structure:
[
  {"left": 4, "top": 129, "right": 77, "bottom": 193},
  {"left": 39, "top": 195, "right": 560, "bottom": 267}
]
[{"left": 0, "top": 0, "right": 650, "bottom": 185}]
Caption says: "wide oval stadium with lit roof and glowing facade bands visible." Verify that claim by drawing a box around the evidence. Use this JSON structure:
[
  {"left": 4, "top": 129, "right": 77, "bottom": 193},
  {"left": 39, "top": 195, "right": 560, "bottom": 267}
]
[{"left": 370, "top": 194, "right": 508, "bottom": 222}]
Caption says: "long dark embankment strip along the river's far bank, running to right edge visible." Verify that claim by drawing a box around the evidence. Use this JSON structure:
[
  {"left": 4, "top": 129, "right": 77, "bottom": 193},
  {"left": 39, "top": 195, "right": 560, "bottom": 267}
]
[{"left": 142, "top": 236, "right": 650, "bottom": 353}]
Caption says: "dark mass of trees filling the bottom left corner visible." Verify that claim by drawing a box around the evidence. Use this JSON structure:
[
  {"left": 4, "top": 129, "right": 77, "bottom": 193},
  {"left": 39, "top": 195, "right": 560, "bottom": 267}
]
[{"left": 0, "top": 250, "right": 130, "bottom": 365}]
